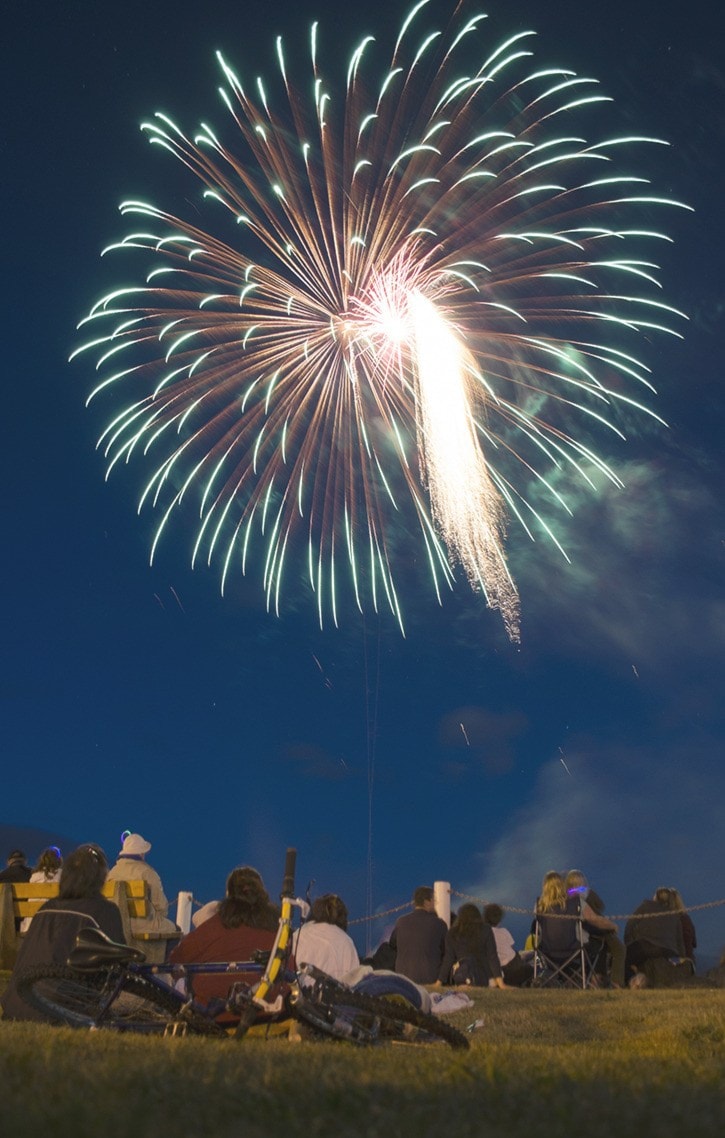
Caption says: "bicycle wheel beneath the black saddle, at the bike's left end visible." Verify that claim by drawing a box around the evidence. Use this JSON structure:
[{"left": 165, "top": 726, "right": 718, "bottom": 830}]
[{"left": 18, "top": 965, "right": 224, "bottom": 1036}]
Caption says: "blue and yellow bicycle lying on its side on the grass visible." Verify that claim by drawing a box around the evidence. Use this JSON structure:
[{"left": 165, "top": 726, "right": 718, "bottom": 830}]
[{"left": 18, "top": 850, "right": 469, "bottom": 1048}]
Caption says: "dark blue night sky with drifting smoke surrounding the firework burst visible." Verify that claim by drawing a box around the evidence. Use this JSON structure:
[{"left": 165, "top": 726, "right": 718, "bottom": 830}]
[{"left": 0, "top": 0, "right": 725, "bottom": 956}]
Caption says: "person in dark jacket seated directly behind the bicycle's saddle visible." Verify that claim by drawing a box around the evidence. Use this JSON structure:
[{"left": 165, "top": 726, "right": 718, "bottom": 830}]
[{"left": 0, "top": 846, "right": 124, "bottom": 1021}]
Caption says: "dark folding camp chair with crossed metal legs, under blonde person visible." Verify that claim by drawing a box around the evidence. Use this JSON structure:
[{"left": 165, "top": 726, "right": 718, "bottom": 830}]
[{"left": 532, "top": 896, "right": 599, "bottom": 988}]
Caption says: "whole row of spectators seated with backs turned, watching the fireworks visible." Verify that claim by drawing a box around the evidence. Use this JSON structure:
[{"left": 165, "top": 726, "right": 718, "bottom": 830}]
[{"left": 0, "top": 833, "right": 725, "bottom": 1020}]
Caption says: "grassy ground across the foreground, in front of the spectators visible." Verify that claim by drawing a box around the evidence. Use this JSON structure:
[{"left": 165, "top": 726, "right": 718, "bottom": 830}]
[{"left": 0, "top": 990, "right": 725, "bottom": 1138}]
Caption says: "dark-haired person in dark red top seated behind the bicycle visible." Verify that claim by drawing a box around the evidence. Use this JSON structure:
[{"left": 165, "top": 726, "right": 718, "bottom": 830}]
[{"left": 168, "top": 866, "right": 279, "bottom": 1020}]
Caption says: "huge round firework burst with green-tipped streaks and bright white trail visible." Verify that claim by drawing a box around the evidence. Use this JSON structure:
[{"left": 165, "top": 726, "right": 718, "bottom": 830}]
[{"left": 74, "top": 2, "right": 687, "bottom": 640}]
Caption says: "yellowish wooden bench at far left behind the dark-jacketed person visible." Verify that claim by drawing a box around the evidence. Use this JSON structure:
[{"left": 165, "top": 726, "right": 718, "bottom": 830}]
[{"left": 0, "top": 880, "right": 180, "bottom": 968}]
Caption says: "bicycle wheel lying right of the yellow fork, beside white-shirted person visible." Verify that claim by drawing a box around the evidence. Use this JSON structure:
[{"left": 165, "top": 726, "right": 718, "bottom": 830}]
[{"left": 293, "top": 984, "right": 470, "bottom": 1050}]
